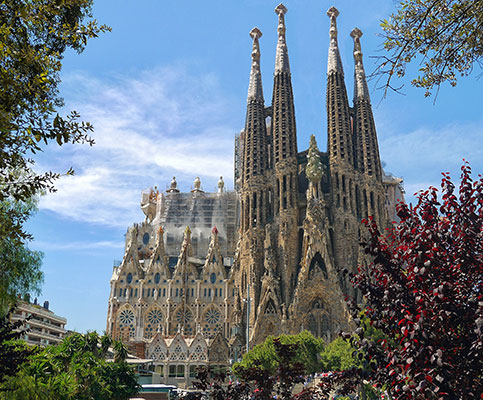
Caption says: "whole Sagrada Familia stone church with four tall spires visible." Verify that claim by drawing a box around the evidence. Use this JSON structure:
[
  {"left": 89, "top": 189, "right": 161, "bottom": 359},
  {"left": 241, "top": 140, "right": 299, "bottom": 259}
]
[{"left": 107, "top": 4, "right": 403, "bottom": 382}]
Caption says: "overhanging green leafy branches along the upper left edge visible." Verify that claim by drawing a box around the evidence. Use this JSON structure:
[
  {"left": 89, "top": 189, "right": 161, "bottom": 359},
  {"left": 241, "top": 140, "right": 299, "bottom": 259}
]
[{"left": 0, "top": 0, "right": 109, "bottom": 242}]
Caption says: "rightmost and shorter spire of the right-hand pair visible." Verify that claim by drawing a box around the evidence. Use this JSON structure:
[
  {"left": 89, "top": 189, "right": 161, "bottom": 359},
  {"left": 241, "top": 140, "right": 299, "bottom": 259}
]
[{"left": 351, "top": 28, "right": 382, "bottom": 181}]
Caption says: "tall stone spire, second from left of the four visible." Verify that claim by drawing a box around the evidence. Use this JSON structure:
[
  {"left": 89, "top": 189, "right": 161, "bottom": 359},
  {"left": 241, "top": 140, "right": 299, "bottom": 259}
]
[{"left": 271, "top": 4, "right": 297, "bottom": 213}]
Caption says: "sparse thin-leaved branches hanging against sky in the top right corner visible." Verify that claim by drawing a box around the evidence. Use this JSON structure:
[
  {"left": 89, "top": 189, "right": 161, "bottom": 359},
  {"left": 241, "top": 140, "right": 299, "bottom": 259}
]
[{"left": 376, "top": 0, "right": 483, "bottom": 96}]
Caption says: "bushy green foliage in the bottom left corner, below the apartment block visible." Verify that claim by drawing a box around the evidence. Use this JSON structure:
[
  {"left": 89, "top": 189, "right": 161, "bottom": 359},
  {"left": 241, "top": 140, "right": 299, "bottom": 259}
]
[{"left": 0, "top": 332, "right": 139, "bottom": 400}]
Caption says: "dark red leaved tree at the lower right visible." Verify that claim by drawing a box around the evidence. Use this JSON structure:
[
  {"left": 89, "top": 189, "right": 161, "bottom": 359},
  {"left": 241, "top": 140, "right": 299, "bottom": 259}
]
[{"left": 353, "top": 164, "right": 483, "bottom": 400}]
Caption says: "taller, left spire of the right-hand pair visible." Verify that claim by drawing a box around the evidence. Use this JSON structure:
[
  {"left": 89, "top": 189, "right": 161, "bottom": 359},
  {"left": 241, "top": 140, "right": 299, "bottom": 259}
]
[{"left": 327, "top": 7, "right": 354, "bottom": 166}]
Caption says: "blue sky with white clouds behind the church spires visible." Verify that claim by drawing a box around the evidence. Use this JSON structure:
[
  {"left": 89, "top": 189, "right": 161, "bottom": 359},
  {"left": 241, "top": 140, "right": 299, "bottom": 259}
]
[{"left": 28, "top": 0, "right": 483, "bottom": 331}]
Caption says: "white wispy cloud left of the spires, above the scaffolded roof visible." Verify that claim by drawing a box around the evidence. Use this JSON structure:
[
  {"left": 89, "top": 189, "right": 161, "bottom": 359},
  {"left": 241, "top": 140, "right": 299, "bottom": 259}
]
[{"left": 38, "top": 68, "right": 238, "bottom": 227}]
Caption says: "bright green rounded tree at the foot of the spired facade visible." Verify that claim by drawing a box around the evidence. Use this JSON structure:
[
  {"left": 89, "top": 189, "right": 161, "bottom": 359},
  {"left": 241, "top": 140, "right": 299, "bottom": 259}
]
[{"left": 234, "top": 331, "right": 324, "bottom": 375}]
